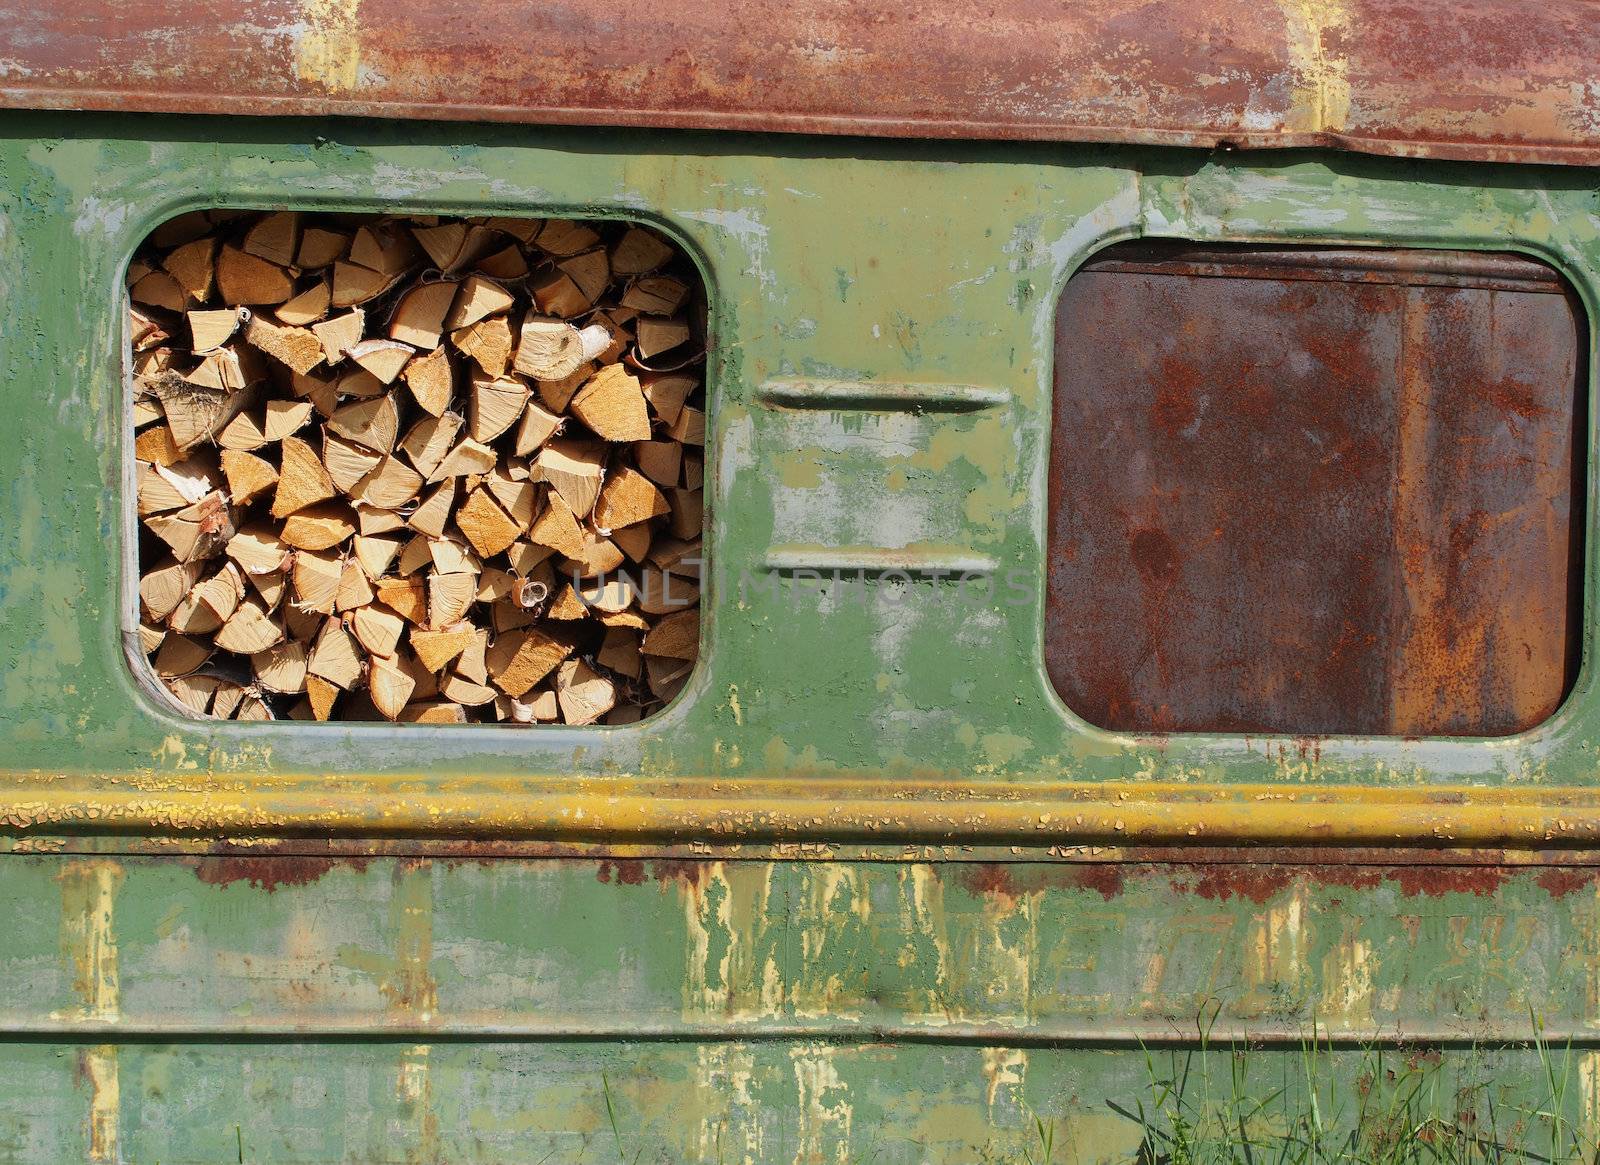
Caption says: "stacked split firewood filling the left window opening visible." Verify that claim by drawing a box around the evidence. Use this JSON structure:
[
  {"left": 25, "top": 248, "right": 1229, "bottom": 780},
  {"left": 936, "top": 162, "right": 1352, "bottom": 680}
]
[{"left": 128, "top": 211, "right": 706, "bottom": 725}]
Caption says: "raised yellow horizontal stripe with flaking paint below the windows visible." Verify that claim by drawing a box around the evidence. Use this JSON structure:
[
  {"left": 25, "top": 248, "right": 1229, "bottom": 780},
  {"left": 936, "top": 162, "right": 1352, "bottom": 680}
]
[{"left": 0, "top": 773, "right": 1600, "bottom": 848}]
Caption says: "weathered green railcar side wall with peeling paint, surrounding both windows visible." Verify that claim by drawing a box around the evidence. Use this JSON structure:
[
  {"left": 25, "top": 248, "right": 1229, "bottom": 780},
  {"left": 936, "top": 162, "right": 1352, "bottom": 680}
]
[{"left": 0, "top": 114, "right": 1600, "bottom": 1163}]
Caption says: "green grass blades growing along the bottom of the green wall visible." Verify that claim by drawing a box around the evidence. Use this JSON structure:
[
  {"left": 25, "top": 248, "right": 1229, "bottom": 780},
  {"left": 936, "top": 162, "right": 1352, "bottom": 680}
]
[{"left": 600, "top": 1008, "right": 1600, "bottom": 1165}]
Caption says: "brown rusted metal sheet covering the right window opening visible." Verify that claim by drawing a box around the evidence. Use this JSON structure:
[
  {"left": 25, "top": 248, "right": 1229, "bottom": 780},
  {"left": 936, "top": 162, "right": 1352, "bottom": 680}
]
[{"left": 1046, "top": 245, "right": 1581, "bottom": 736}]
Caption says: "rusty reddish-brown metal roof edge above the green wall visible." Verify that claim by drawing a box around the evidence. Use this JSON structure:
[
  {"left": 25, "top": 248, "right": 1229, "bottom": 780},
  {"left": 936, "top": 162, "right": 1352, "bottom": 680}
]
[{"left": 0, "top": 0, "right": 1600, "bottom": 165}]
